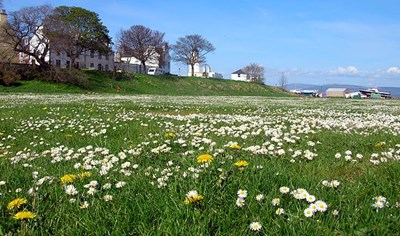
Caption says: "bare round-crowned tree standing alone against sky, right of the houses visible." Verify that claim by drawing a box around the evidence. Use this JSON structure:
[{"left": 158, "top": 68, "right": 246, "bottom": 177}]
[{"left": 171, "top": 34, "right": 215, "bottom": 76}]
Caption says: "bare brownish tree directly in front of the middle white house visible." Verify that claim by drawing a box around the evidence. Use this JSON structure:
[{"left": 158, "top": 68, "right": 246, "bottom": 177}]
[{"left": 117, "top": 25, "right": 166, "bottom": 72}]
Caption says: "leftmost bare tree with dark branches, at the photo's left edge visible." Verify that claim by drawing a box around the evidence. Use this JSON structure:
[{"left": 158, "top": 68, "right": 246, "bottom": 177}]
[{"left": 3, "top": 5, "right": 52, "bottom": 69}]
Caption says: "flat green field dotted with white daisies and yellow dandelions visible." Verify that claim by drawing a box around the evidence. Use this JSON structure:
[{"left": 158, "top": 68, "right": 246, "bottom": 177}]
[{"left": 0, "top": 94, "right": 400, "bottom": 235}]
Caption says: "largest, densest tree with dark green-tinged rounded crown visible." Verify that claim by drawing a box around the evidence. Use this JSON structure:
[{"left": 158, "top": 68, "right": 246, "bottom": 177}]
[{"left": 44, "top": 6, "right": 111, "bottom": 68}]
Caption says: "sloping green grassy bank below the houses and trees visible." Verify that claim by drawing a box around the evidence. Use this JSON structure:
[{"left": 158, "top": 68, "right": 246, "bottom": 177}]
[{"left": 0, "top": 71, "right": 291, "bottom": 97}]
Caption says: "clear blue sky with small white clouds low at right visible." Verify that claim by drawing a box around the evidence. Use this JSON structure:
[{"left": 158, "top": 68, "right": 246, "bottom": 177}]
[{"left": 3, "top": 0, "right": 400, "bottom": 87}]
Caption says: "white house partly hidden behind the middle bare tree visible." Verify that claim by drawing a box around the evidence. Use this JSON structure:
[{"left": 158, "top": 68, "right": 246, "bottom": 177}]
[{"left": 116, "top": 48, "right": 171, "bottom": 75}]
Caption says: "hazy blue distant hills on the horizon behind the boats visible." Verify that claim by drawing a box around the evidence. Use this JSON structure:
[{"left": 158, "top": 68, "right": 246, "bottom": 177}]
[{"left": 287, "top": 84, "right": 400, "bottom": 98}]
